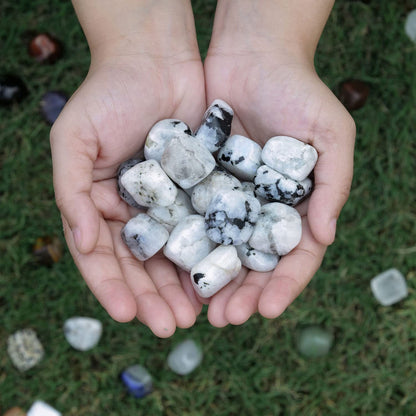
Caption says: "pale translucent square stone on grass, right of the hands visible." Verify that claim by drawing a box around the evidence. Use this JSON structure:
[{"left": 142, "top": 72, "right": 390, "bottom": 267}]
[{"left": 370, "top": 269, "right": 408, "bottom": 306}]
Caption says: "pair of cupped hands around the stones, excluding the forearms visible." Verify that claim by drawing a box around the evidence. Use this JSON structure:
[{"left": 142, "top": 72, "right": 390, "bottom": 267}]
[{"left": 51, "top": 17, "right": 355, "bottom": 337}]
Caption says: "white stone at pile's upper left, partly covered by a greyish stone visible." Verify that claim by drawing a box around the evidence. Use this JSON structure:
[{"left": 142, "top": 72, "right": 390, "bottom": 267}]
[{"left": 144, "top": 119, "right": 192, "bottom": 163}]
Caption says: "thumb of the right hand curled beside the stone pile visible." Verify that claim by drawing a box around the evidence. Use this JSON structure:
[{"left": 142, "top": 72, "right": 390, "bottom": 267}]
[{"left": 308, "top": 112, "right": 355, "bottom": 245}]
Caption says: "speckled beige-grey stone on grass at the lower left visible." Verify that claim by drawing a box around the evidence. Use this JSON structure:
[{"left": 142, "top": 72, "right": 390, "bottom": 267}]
[{"left": 7, "top": 328, "right": 44, "bottom": 371}]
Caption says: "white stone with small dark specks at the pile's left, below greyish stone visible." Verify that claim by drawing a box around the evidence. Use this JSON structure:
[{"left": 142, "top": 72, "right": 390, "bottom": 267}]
[{"left": 120, "top": 160, "right": 178, "bottom": 207}]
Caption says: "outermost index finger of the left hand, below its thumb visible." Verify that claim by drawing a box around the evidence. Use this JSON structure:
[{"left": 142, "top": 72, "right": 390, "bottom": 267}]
[{"left": 63, "top": 219, "right": 136, "bottom": 322}]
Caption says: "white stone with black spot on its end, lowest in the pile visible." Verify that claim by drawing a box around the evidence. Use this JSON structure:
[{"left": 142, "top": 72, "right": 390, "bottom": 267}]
[{"left": 191, "top": 246, "right": 241, "bottom": 298}]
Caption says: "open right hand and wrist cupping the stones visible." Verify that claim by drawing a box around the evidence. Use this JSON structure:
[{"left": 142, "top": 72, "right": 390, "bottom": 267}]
[{"left": 204, "top": 0, "right": 355, "bottom": 327}]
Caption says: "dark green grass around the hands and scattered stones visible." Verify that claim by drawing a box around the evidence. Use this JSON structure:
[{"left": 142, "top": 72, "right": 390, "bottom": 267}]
[{"left": 0, "top": 0, "right": 416, "bottom": 416}]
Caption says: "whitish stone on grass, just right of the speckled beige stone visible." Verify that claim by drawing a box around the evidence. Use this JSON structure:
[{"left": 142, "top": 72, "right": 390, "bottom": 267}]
[{"left": 64, "top": 316, "right": 103, "bottom": 351}]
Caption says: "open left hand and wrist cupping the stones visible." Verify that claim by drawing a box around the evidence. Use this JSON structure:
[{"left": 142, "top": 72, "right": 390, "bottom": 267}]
[{"left": 51, "top": 1, "right": 205, "bottom": 337}]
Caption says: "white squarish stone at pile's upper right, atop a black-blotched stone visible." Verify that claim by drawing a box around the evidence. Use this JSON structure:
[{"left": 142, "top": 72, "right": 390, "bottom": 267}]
[{"left": 261, "top": 136, "right": 318, "bottom": 181}]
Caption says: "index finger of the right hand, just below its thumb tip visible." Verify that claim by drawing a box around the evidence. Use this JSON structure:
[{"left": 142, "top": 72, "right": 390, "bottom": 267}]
[{"left": 258, "top": 218, "right": 326, "bottom": 318}]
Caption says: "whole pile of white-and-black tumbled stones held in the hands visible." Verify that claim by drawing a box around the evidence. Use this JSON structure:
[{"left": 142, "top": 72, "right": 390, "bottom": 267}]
[{"left": 118, "top": 100, "right": 318, "bottom": 297}]
